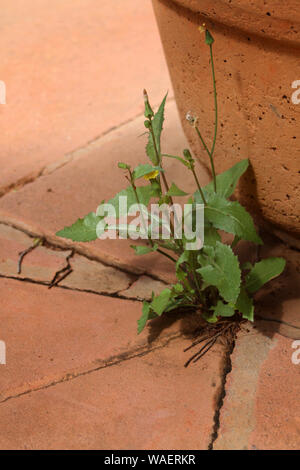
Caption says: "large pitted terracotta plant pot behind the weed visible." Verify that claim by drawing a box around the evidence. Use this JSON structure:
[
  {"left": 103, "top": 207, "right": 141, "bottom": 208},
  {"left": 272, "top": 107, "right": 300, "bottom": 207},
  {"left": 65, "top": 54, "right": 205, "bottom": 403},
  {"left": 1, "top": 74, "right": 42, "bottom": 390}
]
[{"left": 153, "top": 0, "right": 300, "bottom": 239}]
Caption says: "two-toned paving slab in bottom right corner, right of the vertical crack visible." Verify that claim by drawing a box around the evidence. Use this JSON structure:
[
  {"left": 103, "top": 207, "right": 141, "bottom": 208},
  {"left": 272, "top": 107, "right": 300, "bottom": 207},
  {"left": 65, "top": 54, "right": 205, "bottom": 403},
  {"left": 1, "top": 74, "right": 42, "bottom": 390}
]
[{"left": 213, "top": 324, "right": 300, "bottom": 450}]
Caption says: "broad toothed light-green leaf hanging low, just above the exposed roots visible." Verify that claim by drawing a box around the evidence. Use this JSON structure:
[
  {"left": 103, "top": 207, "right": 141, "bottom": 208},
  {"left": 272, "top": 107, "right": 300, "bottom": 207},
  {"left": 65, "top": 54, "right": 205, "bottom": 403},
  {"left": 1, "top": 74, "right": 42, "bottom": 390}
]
[{"left": 197, "top": 242, "right": 241, "bottom": 302}]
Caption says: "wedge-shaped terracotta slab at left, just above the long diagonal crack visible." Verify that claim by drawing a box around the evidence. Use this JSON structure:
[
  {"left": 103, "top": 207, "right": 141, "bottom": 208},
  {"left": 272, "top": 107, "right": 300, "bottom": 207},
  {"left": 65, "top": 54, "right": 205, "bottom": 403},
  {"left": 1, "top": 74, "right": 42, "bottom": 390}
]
[{"left": 0, "top": 278, "right": 180, "bottom": 401}]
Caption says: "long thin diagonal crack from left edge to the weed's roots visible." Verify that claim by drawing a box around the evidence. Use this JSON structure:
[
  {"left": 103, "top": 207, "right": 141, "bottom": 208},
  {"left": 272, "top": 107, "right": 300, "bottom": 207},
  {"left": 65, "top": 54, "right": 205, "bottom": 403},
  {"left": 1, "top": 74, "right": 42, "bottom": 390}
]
[{"left": 0, "top": 333, "right": 181, "bottom": 405}]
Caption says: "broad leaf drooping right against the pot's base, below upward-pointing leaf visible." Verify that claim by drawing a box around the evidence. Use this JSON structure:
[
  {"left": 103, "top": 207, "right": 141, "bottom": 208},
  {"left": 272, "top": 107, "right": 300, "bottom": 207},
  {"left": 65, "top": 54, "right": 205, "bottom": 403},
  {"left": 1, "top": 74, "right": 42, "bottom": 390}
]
[{"left": 204, "top": 194, "right": 262, "bottom": 245}]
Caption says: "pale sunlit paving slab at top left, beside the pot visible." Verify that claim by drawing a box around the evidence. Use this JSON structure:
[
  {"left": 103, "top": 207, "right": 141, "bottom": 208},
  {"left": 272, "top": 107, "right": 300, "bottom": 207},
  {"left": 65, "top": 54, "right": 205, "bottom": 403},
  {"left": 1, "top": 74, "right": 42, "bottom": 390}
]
[{"left": 0, "top": 0, "right": 172, "bottom": 194}]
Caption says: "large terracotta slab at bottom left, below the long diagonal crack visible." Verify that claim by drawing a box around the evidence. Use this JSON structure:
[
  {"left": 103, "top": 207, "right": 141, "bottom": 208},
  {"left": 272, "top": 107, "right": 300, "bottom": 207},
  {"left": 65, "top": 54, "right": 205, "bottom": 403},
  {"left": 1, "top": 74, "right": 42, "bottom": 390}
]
[{"left": 0, "top": 339, "right": 223, "bottom": 450}]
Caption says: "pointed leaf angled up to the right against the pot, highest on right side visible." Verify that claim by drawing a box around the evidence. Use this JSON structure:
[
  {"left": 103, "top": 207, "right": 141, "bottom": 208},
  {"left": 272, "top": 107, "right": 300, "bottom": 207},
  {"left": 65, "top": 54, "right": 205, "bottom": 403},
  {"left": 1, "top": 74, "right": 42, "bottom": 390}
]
[{"left": 202, "top": 158, "right": 249, "bottom": 198}]
